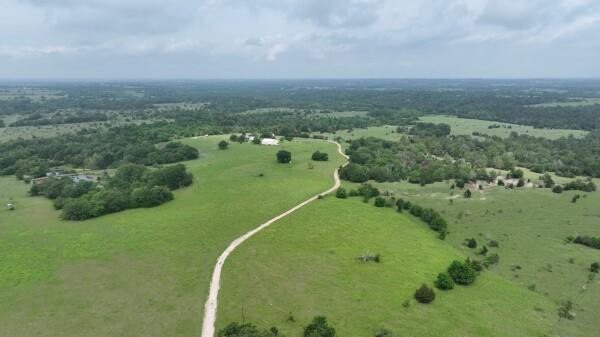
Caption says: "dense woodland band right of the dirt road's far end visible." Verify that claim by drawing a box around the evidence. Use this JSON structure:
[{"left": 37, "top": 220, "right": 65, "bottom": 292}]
[{"left": 340, "top": 132, "right": 600, "bottom": 187}]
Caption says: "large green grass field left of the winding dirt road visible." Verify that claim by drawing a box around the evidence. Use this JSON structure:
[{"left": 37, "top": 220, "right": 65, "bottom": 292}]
[{"left": 0, "top": 136, "right": 342, "bottom": 337}]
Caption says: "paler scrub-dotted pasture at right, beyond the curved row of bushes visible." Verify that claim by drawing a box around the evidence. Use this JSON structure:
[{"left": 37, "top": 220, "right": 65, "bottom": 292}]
[{"left": 377, "top": 182, "right": 600, "bottom": 337}]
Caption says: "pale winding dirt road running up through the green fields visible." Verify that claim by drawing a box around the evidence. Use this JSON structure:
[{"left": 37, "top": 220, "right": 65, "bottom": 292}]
[{"left": 202, "top": 140, "right": 349, "bottom": 337}]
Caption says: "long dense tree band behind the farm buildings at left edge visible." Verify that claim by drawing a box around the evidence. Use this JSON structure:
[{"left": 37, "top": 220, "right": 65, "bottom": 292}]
[{"left": 0, "top": 126, "right": 198, "bottom": 177}]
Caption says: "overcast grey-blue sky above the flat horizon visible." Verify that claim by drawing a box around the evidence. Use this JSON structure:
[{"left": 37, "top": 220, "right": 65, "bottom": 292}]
[{"left": 0, "top": 0, "right": 600, "bottom": 80}]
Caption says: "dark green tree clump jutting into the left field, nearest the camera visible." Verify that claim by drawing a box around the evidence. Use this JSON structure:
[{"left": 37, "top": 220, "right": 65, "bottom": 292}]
[{"left": 30, "top": 164, "right": 192, "bottom": 220}]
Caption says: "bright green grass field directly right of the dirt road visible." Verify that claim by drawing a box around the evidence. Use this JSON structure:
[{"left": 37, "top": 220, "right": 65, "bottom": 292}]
[{"left": 217, "top": 197, "right": 556, "bottom": 337}]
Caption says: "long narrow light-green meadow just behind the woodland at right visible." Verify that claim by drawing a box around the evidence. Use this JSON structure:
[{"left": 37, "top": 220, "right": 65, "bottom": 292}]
[{"left": 419, "top": 115, "right": 587, "bottom": 139}]
